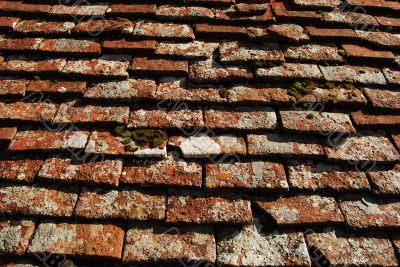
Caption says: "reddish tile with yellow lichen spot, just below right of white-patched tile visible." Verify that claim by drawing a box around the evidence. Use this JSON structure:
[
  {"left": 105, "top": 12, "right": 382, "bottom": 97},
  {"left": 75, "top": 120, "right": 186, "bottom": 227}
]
[{"left": 205, "top": 160, "right": 289, "bottom": 191}]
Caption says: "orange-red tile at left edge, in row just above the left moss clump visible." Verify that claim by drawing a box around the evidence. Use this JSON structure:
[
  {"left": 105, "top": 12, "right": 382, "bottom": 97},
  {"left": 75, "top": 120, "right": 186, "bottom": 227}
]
[{"left": 0, "top": 102, "right": 57, "bottom": 122}]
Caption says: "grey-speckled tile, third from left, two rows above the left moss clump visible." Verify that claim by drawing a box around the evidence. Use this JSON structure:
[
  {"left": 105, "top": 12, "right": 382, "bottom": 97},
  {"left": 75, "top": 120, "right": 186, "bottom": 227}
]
[{"left": 84, "top": 79, "right": 156, "bottom": 101}]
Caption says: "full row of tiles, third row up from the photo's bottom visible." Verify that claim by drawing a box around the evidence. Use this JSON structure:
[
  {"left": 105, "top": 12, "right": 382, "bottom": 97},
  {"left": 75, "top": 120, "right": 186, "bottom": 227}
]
[{"left": 0, "top": 153, "right": 400, "bottom": 196}]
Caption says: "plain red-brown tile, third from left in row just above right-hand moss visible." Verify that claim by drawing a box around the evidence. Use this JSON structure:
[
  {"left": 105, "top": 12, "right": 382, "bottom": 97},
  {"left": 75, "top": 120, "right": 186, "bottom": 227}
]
[{"left": 131, "top": 57, "right": 188, "bottom": 77}]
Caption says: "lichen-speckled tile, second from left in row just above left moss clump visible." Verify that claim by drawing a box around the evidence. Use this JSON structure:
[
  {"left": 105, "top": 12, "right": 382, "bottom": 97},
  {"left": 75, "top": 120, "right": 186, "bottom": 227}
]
[{"left": 54, "top": 102, "right": 129, "bottom": 124}]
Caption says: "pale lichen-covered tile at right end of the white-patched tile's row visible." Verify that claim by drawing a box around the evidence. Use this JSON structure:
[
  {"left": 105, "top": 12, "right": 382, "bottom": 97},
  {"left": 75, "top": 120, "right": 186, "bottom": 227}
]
[{"left": 325, "top": 132, "right": 400, "bottom": 162}]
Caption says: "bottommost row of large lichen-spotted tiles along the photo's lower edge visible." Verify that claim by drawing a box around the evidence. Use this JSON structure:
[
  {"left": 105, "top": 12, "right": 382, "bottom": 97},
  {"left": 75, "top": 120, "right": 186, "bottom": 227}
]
[{"left": 0, "top": 220, "right": 400, "bottom": 267}]
